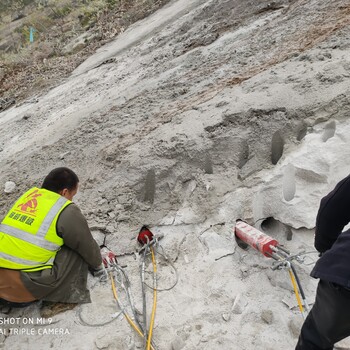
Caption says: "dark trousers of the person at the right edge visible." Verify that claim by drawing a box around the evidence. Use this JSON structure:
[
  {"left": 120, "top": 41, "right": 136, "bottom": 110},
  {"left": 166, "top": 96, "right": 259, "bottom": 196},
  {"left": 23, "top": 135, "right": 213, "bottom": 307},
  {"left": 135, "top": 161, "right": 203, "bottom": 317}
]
[{"left": 295, "top": 280, "right": 350, "bottom": 350}]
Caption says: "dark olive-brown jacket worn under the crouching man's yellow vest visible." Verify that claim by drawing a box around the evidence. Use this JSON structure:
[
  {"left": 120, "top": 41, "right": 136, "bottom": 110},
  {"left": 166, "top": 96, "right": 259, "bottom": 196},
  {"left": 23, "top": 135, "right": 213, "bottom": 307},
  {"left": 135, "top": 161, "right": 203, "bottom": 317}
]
[{"left": 21, "top": 204, "right": 102, "bottom": 303}]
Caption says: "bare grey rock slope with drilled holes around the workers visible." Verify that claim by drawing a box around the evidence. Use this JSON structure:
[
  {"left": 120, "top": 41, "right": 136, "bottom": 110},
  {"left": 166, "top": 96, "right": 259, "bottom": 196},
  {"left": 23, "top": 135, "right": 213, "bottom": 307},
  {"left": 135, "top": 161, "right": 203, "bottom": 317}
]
[{"left": 0, "top": 0, "right": 350, "bottom": 350}]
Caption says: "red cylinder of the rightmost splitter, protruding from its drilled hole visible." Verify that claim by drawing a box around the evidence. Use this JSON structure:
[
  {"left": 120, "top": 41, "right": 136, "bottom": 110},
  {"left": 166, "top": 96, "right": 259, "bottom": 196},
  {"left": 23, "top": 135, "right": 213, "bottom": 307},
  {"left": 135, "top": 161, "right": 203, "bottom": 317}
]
[{"left": 235, "top": 221, "right": 278, "bottom": 257}]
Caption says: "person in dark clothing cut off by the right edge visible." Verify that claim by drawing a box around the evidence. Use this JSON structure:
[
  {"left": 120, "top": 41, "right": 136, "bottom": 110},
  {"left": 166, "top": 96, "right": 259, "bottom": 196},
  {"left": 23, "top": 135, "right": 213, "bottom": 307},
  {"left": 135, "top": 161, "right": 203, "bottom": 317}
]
[{"left": 295, "top": 175, "right": 350, "bottom": 350}]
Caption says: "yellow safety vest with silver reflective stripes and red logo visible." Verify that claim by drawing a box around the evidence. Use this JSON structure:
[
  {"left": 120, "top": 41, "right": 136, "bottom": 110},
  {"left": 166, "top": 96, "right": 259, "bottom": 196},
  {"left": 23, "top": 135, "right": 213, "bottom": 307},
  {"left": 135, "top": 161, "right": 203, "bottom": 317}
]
[{"left": 0, "top": 187, "right": 72, "bottom": 271}]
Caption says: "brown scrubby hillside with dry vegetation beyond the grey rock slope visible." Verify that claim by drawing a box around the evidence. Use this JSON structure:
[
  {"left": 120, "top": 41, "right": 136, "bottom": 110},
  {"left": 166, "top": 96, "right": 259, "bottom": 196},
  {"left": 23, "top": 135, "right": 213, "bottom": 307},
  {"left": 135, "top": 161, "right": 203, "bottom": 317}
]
[{"left": 0, "top": 0, "right": 169, "bottom": 106}]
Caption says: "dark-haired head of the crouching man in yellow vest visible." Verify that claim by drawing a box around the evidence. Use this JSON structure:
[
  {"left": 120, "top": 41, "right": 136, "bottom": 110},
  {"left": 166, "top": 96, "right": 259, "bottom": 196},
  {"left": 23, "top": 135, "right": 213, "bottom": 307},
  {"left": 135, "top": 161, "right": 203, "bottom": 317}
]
[{"left": 41, "top": 167, "right": 79, "bottom": 200}]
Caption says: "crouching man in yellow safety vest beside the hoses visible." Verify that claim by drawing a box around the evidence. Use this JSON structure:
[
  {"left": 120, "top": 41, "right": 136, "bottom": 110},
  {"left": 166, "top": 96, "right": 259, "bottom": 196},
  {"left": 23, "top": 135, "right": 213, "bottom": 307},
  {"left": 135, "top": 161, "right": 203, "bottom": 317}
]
[{"left": 0, "top": 168, "right": 103, "bottom": 311}]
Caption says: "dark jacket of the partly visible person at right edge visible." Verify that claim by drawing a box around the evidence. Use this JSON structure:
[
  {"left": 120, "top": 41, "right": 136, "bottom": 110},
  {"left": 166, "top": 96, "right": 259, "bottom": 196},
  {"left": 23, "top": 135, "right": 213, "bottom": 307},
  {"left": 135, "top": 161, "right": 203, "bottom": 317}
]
[{"left": 311, "top": 175, "right": 350, "bottom": 288}]
